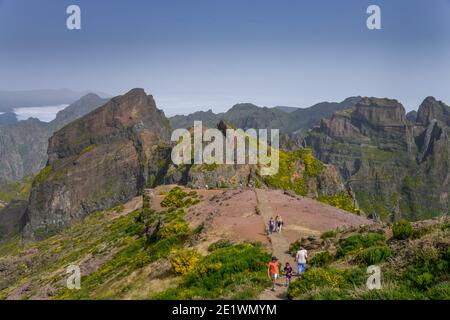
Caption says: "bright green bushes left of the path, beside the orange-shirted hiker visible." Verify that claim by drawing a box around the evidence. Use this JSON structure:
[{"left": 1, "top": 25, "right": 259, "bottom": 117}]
[{"left": 155, "top": 243, "right": 270, "bottom": 300}]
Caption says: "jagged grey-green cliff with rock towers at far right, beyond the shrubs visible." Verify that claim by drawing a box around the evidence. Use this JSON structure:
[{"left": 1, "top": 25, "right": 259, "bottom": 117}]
[{"left": 306, "top": 97, "right": 450, "bottom": 219}]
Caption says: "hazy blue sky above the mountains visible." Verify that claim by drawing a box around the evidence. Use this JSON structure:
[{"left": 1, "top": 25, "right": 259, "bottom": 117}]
[{"left": 0, "top": 0, "right": 450, "bottom": 115}]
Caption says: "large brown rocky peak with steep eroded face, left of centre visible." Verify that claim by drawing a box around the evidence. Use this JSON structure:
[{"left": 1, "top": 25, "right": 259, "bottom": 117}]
[{"left": 26, "top": 89, "right": 170, "bottom": 237}]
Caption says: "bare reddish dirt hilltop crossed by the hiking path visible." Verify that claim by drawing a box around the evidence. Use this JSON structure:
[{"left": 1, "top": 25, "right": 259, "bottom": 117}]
[{"left": 152, "top": 186, "right": 373, "bottom": 300}]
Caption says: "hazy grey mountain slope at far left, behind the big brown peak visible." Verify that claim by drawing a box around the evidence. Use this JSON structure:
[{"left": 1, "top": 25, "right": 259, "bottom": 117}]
[{"left": 0, "top": 94, "right": 107, "bottom": 186}]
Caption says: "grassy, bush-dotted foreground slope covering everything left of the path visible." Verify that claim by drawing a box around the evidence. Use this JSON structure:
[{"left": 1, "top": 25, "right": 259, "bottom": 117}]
[{"left": 0, "top": 188, "right": 269, "bottom": 299}]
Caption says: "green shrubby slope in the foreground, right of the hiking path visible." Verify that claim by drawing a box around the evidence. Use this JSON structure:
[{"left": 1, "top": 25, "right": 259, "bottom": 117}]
[{"left": 288, "top": 219, "right": 450, "bottom": 300}]
